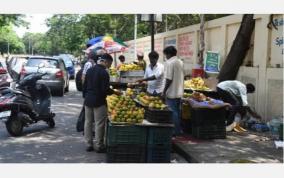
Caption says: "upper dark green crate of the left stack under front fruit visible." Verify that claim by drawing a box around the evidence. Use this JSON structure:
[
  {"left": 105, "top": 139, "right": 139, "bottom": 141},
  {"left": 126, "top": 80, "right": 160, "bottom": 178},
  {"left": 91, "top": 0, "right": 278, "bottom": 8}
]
[{"left": 107, "top": 123, "right": 147, "bottom": 146}]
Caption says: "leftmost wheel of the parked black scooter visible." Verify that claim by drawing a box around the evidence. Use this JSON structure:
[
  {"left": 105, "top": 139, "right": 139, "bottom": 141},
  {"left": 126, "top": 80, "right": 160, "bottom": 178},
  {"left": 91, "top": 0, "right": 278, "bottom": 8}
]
[{"left": 6, "top": 116, "right": 24, "bottom": 137}]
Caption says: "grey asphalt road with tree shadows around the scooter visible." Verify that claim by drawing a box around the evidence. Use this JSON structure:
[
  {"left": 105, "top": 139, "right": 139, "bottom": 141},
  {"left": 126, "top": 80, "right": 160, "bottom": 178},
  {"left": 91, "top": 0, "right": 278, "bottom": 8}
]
[{"left": 0, "top": 80, "right": 186, "bottom": 163}]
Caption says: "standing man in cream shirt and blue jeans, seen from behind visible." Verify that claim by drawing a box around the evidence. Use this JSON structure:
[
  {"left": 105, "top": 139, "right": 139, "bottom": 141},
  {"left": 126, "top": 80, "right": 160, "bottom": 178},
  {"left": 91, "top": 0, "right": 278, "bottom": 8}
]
[{"left": 162, "top": 46, "right": 184, "bottom": 136}]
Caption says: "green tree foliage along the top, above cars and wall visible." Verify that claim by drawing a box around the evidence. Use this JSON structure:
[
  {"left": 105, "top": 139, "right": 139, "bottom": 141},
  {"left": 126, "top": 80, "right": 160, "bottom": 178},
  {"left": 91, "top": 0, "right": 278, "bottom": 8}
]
[{"left": 0, "top": 14, "right": 231, "bottom": 55}]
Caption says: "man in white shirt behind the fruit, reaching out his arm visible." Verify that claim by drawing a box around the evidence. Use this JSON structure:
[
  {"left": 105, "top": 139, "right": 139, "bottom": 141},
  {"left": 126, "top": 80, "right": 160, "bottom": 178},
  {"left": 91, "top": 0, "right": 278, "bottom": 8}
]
[{"left": 138, "top": 51, "right": 165, "bottom": 96}]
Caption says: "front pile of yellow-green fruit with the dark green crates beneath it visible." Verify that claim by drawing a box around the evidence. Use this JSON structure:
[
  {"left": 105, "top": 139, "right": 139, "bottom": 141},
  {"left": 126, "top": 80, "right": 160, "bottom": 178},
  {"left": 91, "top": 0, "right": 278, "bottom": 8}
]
[{"left": 106, "top": 92, "right": 174, "bottom": 163}]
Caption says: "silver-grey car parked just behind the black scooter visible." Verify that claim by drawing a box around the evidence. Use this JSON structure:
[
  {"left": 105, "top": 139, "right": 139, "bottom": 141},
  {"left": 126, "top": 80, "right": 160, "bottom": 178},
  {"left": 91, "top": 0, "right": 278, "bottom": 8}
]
[{"left": 21, "top": 56, "right": 69, "bottom": 96}]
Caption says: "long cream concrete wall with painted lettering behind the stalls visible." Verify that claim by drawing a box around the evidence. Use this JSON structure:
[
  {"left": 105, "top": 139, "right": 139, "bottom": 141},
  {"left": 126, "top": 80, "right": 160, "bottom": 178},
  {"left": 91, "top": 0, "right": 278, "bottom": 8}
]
[{"left": 122, "top": 14, "right": 284, "bottom": 120}]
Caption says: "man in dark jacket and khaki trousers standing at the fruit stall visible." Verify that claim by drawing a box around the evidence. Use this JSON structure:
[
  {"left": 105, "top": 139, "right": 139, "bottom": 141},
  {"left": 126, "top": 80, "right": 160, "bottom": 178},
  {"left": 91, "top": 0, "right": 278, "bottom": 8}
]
[{"left": 83, "top": 54, "right": 121, "bottom": 153}]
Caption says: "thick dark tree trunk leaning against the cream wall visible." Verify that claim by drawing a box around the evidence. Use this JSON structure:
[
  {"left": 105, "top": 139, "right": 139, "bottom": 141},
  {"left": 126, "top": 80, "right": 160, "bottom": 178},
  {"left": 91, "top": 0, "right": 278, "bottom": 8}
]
[{"left": 218, "top": 14, "right": 255, "bottom": 82}]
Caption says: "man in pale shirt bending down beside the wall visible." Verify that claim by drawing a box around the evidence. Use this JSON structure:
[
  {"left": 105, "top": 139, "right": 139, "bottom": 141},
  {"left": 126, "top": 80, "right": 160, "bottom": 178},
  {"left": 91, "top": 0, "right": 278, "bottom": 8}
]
[{"left": 217, "top": 80, "right": 260, "bottom": 125}]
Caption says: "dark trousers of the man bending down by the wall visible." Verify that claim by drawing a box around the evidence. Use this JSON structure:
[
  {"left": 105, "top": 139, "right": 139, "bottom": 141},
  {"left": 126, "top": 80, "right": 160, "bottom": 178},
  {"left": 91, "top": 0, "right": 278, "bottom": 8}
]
[{"left": 217, "top": 87, "right": 245, "bottom": 125}]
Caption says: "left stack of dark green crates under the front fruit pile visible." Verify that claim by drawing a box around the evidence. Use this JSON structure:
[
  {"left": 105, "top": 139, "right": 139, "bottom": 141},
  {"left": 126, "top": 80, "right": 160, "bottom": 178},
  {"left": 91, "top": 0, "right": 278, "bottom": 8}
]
[{"left": 107, "top": 123, "right": 147, "bottom": 163}]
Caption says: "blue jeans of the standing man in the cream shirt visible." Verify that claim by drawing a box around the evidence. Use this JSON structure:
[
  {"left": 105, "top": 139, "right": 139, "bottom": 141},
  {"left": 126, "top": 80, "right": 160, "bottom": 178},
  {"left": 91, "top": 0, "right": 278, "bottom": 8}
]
[{"left": 166, "top": 98, "right": 182, "bottom": 135}]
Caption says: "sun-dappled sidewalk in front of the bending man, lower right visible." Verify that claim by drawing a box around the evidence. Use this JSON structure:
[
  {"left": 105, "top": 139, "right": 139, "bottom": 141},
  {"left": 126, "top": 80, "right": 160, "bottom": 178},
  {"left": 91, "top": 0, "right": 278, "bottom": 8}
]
[{"left": 173, "top": 132, "right": 283, "bottom": 163}]
